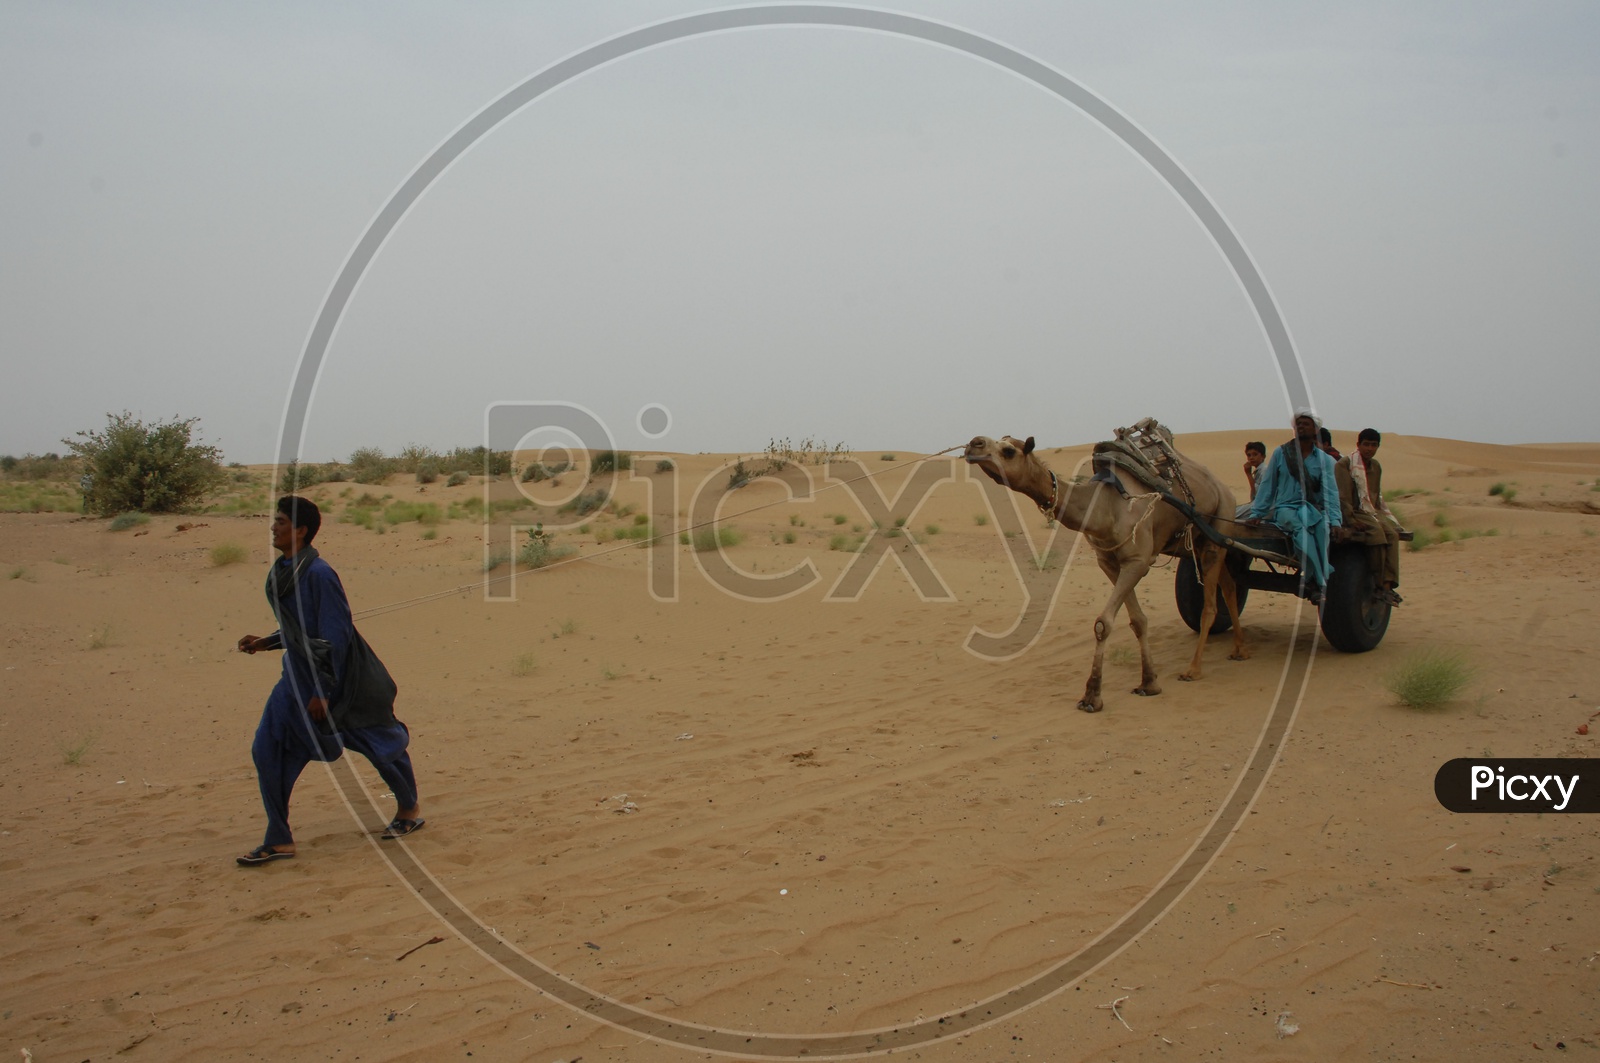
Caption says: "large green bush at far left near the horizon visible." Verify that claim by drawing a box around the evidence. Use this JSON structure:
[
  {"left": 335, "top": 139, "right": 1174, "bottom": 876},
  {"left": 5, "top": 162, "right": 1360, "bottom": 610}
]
[{"left": 62, "top": 411, "right": 227, "bottom": 517}]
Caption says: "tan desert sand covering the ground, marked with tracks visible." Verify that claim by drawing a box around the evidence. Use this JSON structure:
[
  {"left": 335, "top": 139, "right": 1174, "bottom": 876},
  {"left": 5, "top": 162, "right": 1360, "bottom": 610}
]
[{"left": 0, "top": 426, "right": 1600, "bottom": 1061}]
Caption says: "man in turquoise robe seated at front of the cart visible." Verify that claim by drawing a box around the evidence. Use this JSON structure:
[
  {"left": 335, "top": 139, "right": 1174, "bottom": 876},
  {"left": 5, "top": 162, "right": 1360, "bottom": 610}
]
[{"left": 1248, "top": 410, "right": 1341, "bottom": 604}]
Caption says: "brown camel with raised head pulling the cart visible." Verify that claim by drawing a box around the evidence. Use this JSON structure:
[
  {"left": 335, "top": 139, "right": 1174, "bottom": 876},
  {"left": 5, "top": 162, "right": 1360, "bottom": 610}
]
[{"left": 962, "top": 435, "right": 1250, "bottom": 712}]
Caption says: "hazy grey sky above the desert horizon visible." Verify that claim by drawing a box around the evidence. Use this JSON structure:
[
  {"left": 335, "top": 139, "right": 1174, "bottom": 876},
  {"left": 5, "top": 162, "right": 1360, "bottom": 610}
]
[{"left": 0, "top": 0, "right": 1600, "bottom": 461}]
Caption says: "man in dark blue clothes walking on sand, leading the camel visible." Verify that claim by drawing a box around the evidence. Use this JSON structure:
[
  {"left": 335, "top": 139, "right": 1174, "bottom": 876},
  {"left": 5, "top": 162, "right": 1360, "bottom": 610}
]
[{"left": 238, "top": 496, "right": 424, "bottom": 866}]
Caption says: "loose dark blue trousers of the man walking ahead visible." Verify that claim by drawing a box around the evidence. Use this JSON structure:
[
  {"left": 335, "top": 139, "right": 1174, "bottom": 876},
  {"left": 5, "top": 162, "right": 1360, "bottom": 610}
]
[{"left": 250, "top": 680, "right": 416, "bottom": 845}]
